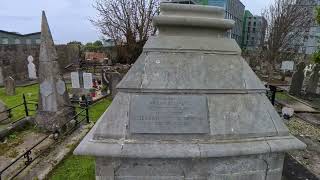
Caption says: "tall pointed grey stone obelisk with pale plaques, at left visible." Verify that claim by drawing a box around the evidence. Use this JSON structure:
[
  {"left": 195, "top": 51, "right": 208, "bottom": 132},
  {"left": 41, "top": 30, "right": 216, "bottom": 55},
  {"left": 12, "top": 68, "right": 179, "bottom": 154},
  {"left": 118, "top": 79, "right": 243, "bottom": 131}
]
[{"left": 36, "top": 12, "right": 74, "bottom": 131}]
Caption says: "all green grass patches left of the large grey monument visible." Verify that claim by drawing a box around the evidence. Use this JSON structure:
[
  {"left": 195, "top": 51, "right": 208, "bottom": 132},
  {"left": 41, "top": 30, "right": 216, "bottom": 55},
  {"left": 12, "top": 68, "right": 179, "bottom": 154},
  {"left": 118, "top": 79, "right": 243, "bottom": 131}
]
[{"left": 0, "top": 84, "right": 111, "bottom": 180}]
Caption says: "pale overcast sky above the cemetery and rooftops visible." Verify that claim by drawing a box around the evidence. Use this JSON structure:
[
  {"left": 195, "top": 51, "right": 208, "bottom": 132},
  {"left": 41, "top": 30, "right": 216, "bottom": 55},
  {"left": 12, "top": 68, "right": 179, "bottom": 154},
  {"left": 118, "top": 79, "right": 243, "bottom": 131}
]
[{"left": 0, "top": 0, "right": 272, "bottom": 44}]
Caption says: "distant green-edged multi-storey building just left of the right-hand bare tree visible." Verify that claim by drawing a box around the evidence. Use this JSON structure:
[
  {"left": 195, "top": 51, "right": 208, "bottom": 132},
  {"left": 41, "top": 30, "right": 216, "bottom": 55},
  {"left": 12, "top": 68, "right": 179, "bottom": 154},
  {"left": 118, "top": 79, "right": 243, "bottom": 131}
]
[{"left": 241, "top": 10, "right": 267, "bottom": 50}]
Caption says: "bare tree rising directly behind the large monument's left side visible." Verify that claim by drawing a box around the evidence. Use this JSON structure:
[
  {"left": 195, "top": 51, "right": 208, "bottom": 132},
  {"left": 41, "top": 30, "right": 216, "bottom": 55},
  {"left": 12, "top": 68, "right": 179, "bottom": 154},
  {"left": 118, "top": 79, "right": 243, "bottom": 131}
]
[{"left": 91, "top": 0, "right": 159, "bottom": 63}]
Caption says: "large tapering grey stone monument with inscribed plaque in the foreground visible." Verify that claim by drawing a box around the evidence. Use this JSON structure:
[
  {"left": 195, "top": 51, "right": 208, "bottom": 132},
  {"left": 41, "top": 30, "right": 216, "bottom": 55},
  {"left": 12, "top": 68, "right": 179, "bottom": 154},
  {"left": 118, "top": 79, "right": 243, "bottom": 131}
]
[{"left": 75, "top": 3, "right": 305, "bottom": 180}]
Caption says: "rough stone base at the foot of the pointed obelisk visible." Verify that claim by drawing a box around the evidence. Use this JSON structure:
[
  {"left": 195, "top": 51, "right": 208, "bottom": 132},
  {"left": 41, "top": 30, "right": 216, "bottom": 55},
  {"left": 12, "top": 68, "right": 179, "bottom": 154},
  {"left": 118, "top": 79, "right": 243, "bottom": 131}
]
[{"left": 35, "top": 107, "right": 75, "bottom": 132}]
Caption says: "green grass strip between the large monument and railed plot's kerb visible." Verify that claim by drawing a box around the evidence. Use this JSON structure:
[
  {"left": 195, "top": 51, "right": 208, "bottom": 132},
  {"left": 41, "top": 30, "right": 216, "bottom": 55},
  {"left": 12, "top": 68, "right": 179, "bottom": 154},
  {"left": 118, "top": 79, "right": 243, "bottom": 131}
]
[{"left": 48, "top": 99, "right": 111, "bottom": 180}]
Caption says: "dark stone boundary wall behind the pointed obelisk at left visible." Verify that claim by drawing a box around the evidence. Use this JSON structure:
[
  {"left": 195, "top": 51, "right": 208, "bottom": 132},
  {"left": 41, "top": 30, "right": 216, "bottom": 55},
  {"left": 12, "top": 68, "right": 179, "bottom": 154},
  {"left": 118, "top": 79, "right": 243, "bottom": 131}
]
[{"left": 0, "top": 45, "right": 80, "bottom": 84}]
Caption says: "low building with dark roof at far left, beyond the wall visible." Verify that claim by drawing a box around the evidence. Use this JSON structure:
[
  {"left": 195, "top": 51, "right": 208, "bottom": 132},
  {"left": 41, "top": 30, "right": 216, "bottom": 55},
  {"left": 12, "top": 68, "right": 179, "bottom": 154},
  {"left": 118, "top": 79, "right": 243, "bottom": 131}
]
[{"left": 0, "top": 30, "right": 41, "bottom": 45}]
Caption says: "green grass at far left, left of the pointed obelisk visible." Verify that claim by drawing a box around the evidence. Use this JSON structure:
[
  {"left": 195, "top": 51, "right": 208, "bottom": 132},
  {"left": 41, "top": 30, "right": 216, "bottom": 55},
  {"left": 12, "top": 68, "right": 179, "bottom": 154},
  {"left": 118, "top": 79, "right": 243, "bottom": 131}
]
[{"left": 0, "top": 84, "right": 39, "bottom": 121}]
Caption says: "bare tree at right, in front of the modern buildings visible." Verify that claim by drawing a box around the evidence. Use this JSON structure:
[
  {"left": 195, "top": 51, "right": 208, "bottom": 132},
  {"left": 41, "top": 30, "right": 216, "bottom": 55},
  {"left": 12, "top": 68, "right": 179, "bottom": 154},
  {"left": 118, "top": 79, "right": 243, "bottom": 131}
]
[{"left": 263, "top": 0, "right": 314, "bottom": 80}]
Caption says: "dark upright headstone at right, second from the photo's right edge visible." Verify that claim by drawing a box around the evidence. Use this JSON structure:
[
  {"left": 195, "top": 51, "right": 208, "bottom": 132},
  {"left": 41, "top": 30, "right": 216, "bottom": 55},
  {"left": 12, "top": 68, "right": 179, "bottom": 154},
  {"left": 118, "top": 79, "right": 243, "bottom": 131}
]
[{"left": 289, "top": 62, "right": 306, "bottom": 95}]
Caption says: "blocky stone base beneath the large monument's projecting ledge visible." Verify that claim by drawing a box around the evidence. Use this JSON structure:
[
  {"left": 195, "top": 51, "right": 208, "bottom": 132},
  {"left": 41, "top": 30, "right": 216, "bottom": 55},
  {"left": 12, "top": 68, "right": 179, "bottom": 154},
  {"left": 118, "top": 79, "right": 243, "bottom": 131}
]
[{"left": 96, "top": 153, "right": 284, "bottom": 180}]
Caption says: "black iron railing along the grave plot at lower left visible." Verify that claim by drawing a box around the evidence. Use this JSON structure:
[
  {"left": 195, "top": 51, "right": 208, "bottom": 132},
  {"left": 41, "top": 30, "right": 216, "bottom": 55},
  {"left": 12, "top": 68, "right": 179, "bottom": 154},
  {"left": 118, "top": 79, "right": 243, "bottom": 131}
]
[{"left": 0, "top": 97, "right": 90, "bottom": 180}]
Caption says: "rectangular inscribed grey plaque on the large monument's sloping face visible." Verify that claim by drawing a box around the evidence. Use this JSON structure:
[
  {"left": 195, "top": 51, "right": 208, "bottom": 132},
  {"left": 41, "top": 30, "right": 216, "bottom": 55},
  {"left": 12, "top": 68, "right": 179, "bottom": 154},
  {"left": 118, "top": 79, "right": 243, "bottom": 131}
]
[{"left": 129, "top": 95, "right": 209, "bottom": 134}]
